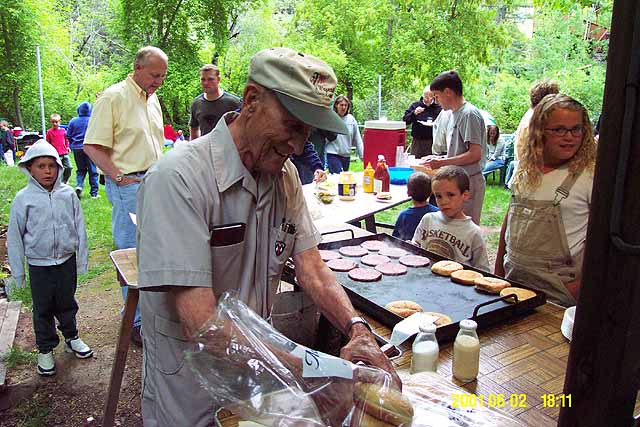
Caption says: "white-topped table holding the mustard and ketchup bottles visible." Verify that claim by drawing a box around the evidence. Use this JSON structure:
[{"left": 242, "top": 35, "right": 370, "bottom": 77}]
[{"left": 302, "top": 172, "right": 411, "bottom": 233}]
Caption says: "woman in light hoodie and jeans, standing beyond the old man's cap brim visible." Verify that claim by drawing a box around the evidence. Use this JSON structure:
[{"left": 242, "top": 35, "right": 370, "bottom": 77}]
[{"left": 325, "top": 95, "right": 362, "bottom": 173}]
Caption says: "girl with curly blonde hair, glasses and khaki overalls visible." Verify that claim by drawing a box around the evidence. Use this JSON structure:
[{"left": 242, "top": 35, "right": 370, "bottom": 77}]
[{"left": 495, "top": 94, "right": 596, "bottom": 305}]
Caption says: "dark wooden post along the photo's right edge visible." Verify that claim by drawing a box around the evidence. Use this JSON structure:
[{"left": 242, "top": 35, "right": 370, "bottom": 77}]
[{"left": 558, "top": 0, "right": 640, "bottom": 427}]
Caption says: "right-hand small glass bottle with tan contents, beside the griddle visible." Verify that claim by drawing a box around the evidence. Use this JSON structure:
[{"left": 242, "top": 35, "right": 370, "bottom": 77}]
[{"left": 453, "top": 319, "right": 480, "bottom": 382}]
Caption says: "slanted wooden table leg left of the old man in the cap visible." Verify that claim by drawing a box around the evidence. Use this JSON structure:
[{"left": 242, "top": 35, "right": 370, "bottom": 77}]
[{"left": 102, "top": 287, "right": 139, "bottom": 427}]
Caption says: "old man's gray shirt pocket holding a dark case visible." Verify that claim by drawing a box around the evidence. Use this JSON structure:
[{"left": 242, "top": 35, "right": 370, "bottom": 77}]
[{"left": 211, "top": 241, "right": 252, "bottom": 298}]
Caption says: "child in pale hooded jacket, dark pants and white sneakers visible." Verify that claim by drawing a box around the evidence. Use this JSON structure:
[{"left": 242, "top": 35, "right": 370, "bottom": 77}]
[{"left": 7, "top": 140, "right": 93, "bottom": 376}]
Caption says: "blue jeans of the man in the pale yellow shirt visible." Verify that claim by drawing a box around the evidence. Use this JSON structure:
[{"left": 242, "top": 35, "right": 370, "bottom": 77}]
[{"left": 104, "top": 174, "right": 144, "bottom": 326}]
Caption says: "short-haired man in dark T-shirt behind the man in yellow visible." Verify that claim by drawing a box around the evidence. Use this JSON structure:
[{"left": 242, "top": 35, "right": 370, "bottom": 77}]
[{"left": 189, "top": 64, "right": 242, "bottom": 141}]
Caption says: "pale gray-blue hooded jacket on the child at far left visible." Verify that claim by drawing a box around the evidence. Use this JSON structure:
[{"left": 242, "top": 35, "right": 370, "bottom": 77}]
[{"left": 7, "top": 140, "right": 89, "bottom": 287}]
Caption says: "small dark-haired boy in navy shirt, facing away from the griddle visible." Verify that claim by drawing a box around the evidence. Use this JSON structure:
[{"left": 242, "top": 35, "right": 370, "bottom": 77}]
[{"left": 393, "top": 172, "right": 439, "bottom": 240}]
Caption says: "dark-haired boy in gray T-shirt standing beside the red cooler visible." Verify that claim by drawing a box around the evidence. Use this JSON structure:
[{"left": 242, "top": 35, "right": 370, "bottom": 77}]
[{"left": 425, "top": 70, "right": 487, "bottom": 225}]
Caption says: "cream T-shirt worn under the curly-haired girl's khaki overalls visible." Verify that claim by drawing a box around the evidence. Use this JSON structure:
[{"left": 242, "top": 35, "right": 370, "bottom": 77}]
[{"left": 530, "top": 166, "right": 593, "bottom": 257}]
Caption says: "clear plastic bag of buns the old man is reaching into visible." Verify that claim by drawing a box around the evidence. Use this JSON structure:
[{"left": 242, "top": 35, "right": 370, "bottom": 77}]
[{"left": 185, "top": 294, "right": 518, "bottom": 427}]
